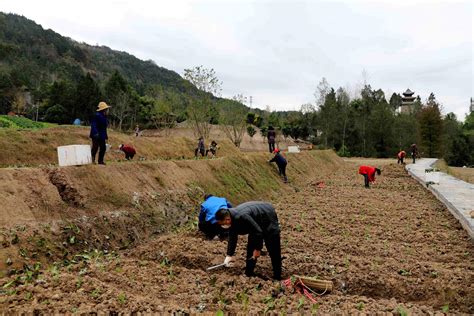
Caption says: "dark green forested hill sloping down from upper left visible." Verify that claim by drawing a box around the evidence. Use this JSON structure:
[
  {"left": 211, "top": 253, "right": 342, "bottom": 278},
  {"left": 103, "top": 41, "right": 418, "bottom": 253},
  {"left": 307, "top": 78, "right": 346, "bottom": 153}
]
[{"left": 0, "top": 12, "right": 196, "bottom": 94}]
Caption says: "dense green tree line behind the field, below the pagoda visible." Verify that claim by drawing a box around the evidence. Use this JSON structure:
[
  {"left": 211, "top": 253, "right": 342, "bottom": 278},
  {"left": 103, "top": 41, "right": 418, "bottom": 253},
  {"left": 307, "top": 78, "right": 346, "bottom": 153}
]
[{"left": 250, "top": 78, "right": 474, "bottom": 166}]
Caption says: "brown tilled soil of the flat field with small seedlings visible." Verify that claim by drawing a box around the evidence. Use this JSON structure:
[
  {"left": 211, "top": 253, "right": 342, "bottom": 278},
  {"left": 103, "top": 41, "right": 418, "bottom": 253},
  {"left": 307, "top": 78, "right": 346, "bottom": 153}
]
[{"left": 1, "top": 163, "right": 474, "bottom": 315}]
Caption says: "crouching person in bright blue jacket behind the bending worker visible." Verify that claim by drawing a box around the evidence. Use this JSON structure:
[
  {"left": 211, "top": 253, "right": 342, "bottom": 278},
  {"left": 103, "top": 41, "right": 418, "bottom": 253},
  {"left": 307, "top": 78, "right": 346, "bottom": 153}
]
[{"left": 198, "top": 194, "right": 232, "bottom": 239}]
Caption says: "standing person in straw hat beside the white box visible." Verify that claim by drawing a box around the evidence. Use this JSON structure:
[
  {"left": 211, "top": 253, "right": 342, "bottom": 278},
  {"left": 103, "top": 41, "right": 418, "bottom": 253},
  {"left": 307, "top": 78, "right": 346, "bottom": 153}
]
[{"left": 89, "top": 102, "right": 110, "bottom": 165}]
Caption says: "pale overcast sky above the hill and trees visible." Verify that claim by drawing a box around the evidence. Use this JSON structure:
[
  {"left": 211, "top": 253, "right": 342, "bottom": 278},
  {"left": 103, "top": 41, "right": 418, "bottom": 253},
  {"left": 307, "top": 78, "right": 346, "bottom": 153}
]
[{"left": 0, "top": 0, "right": 474, "bottom": 120}]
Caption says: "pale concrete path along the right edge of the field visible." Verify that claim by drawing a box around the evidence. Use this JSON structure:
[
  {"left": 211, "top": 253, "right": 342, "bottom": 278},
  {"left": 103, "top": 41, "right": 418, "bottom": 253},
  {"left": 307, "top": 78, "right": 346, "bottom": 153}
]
[{"left": 405, "top": 158, "right": 474, "bottom": 240}]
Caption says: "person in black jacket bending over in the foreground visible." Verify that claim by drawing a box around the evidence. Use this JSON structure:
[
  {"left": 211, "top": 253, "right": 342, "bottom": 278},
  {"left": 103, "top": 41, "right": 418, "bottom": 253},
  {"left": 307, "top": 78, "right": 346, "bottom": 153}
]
[{"left": 216, "top": 202, "right": 281, "bottom": 280}]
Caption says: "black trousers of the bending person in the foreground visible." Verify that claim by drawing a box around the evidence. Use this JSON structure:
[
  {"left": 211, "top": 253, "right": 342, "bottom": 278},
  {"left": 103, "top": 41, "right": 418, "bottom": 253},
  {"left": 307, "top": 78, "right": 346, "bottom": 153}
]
[{"left": 245, "top": 233, "right": 281, "bottom": 280}]
